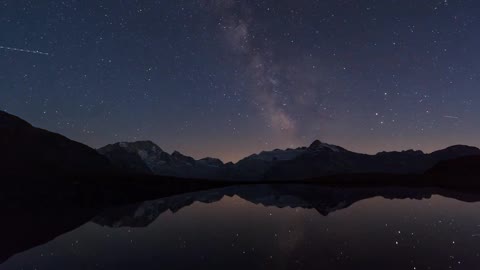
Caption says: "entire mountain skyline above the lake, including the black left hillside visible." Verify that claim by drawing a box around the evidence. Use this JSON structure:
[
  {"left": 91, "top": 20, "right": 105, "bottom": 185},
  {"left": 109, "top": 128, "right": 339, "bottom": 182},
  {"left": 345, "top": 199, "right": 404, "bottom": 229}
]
[{"left": 0, "top": 111, "right": 480, "bottom": 182}]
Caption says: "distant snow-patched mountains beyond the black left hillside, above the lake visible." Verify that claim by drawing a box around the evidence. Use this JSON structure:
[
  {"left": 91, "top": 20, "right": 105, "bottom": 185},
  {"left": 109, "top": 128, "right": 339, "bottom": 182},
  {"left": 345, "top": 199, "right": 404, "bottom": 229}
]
[{"left": 98, "top": 140, "right": 480, "bottom": 181}]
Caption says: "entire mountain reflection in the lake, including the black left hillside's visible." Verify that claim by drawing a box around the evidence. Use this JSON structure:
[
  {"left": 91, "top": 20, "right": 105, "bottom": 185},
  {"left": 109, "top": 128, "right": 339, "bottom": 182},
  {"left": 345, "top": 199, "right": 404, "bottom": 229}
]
[{"left": 0, "top": 182, "right": 480, "bottom": 262}]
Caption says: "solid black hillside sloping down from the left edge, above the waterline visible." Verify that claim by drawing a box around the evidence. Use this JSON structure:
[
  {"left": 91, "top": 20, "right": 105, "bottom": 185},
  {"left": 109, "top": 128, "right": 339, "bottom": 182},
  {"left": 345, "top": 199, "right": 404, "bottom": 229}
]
[{"left": 0, "top": 111, "right": 112, "bottom": 176}]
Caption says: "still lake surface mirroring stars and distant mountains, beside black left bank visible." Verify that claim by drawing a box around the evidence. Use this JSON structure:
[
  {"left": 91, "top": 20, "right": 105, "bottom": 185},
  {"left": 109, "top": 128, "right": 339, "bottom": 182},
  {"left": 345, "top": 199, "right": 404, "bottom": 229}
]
[{"left": 0, "top": 186, "right": 480, "bottom": 270}]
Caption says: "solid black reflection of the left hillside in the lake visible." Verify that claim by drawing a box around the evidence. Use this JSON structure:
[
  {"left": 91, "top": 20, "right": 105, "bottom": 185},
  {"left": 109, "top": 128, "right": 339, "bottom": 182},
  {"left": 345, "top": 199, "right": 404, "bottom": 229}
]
[{"left": 0, "top": 178, "right": 226, "bottom": 263}]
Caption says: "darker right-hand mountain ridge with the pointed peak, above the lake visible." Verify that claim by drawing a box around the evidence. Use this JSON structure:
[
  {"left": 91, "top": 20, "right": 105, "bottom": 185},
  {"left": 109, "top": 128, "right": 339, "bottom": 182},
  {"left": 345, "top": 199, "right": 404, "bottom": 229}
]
[{"left": 265, "top": 142, "right": 480, "bottom": 180}]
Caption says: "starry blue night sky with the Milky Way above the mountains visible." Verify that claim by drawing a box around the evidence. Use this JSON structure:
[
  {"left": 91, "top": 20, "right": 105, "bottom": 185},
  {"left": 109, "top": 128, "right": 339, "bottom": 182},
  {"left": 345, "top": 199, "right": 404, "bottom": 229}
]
[{"left": 0, "top": 0, "right": 480, "bottom": 161}]
